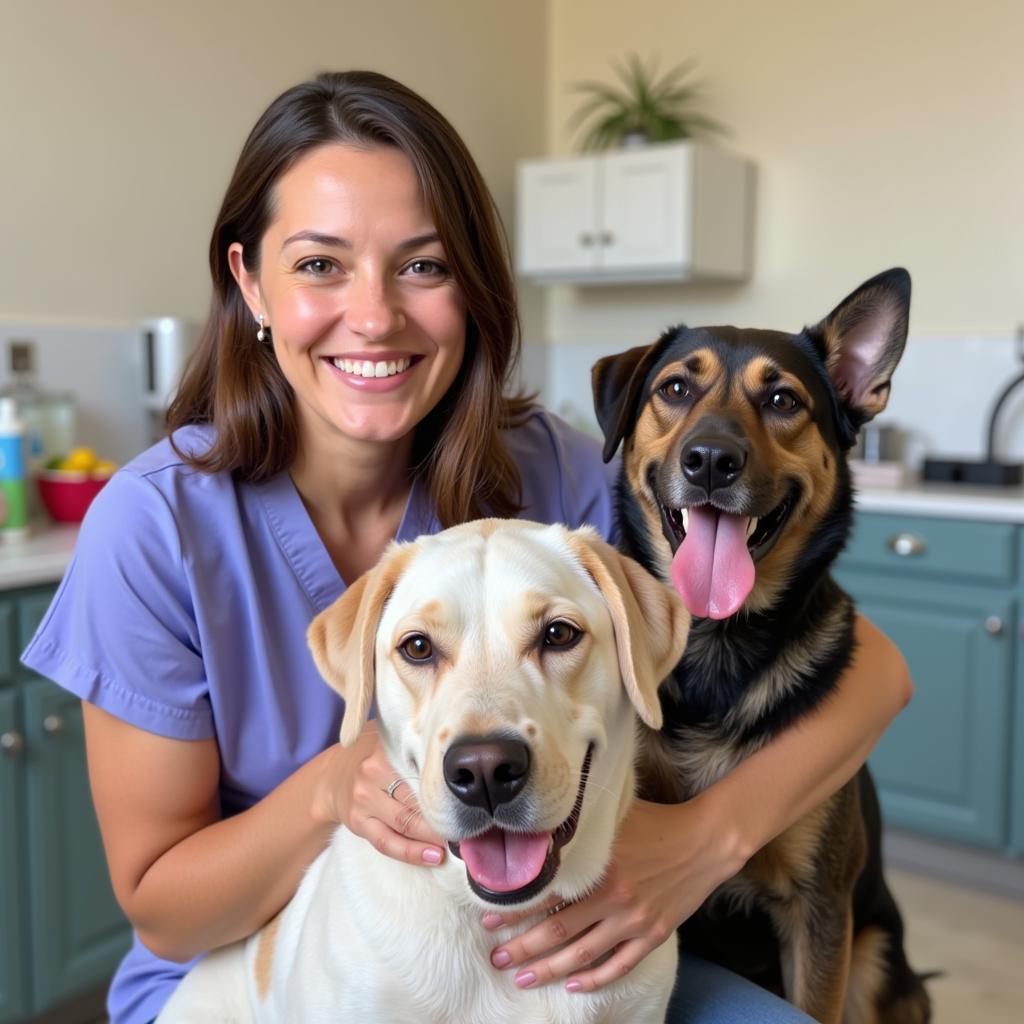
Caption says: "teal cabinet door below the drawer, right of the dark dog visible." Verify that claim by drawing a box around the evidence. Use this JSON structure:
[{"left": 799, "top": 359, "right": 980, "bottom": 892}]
[{"left": 839, "top": 571, "right": 1015, "bottom": 848}]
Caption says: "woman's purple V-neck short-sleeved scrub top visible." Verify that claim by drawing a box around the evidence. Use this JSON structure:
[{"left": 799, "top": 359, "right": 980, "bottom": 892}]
[{"left": 22, "top": 410, "right": 614, "bottom": 1024}]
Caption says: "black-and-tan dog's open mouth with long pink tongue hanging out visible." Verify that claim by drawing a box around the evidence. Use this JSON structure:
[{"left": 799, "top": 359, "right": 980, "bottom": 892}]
[{"left": 659, "top": 486, "right": 800, "bottom": 618}]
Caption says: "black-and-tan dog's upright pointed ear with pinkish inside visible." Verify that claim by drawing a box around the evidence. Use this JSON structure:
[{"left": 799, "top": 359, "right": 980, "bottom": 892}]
[{"left": 809, "top": 267, "right": 910, "bottom": 426}]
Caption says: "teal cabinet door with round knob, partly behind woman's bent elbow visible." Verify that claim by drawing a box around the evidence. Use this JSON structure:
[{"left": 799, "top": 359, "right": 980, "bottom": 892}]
[{"left": 24, "top": 680, "right": 131, "bottom": 1013}]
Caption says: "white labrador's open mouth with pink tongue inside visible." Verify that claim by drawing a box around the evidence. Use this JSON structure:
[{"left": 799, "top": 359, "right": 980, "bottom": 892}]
[{"left": 449, "top": 744, "right": 594, "bottom": 905}]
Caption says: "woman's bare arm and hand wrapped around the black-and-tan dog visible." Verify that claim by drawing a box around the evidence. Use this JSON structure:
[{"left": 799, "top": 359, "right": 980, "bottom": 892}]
[{"left": 484, "top": 615, "right": 912, "bottom": 991}]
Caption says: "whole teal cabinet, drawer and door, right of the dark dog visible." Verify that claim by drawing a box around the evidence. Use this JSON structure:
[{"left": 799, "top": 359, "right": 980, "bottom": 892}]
[{"left": 837, "top": 512, "right": 1024, "bottom": 853}]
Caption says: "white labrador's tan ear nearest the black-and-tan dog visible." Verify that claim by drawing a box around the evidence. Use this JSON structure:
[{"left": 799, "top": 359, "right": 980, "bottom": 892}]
[{"left": 569, "top": 527, "right": 690, "bottom": 729}]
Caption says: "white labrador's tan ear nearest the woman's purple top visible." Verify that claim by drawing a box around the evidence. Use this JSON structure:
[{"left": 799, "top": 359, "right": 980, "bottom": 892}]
[{"left": 306, "top": 545, "right": 414, "bottom": 746}]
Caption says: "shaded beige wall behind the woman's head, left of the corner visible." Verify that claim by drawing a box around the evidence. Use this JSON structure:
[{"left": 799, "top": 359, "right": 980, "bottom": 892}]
[{"left": 0, "top": 0, "right": 547, "bottom": 324}]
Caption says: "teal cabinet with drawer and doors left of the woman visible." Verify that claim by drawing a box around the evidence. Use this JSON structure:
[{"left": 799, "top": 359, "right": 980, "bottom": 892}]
[{"left": 0, "top": 588, "right": 131, "bottom": 1024}]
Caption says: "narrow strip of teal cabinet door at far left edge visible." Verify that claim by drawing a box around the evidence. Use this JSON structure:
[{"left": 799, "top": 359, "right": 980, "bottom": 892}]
[{"left": 0, "top": 689, "right": 29, "bottom": 1024}]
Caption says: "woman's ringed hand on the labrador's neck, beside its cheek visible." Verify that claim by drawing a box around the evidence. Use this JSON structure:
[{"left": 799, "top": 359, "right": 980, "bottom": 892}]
[{"left": 313, "top": 720, "right": 444, "bottom": 864}]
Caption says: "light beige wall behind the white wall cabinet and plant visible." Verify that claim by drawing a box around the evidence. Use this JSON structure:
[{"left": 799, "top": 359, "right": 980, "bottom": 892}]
[{"left": 547, "top": 0, "right": 1024, "bottom": 343}]
